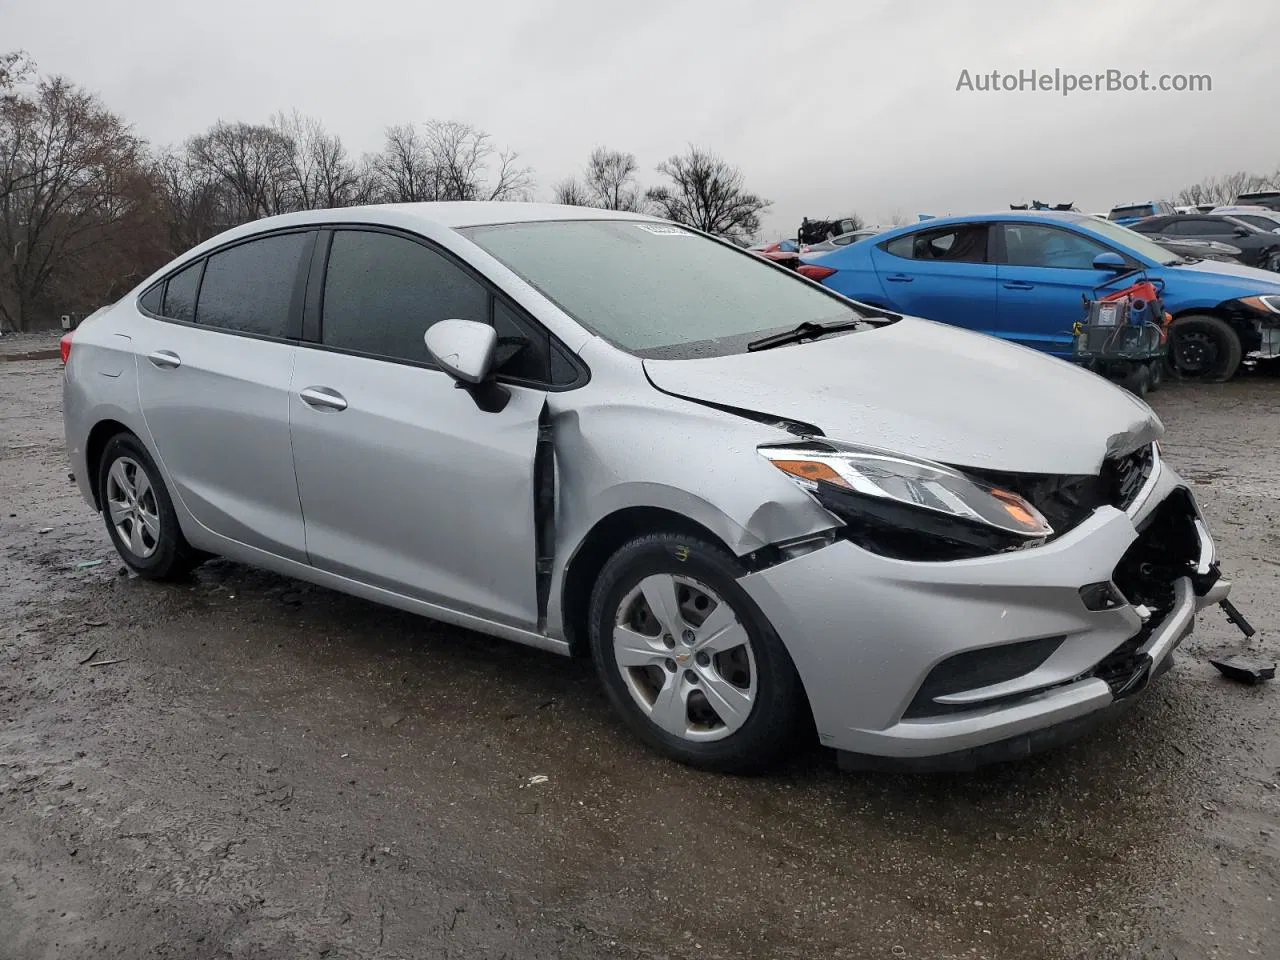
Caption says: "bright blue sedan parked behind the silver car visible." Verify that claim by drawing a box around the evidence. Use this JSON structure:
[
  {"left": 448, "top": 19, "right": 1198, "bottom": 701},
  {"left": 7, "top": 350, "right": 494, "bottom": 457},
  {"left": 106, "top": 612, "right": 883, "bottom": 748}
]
[{"left": 800, "top": 211, "right": 1280, "bottom": 381}]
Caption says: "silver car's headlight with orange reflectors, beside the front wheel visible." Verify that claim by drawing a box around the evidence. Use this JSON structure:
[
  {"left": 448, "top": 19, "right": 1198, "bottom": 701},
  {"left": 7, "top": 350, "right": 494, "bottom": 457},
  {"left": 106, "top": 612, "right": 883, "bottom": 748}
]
[{"left": 760, "top": 440, "right": 1053, "bottom": 559}]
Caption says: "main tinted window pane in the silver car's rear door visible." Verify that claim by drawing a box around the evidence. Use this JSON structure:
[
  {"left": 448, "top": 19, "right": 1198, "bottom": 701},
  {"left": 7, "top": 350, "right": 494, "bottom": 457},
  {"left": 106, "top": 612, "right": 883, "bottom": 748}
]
[{"left": 195, "top": 233, "right": 310, "bottom": 337}]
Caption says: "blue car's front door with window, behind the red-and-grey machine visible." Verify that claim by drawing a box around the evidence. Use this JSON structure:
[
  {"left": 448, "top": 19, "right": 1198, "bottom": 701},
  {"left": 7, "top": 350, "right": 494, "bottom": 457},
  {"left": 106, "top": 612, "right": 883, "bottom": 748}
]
[{"left": 992, "top": 221, "right": 1129, "bottom": 356}]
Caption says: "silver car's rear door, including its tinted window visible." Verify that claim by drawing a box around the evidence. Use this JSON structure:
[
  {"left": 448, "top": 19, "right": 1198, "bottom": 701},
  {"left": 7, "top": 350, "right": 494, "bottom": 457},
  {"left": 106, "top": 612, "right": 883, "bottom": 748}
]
[{"left": 134, "top": 230, "right": 315, "bottom": 561}]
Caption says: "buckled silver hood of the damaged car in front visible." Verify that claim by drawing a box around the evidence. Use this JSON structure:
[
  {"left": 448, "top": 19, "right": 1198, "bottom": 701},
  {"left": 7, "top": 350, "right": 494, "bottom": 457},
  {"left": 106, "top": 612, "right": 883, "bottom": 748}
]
[{"left": 644, "top": 317, "right": 1164, "bottom": 475}]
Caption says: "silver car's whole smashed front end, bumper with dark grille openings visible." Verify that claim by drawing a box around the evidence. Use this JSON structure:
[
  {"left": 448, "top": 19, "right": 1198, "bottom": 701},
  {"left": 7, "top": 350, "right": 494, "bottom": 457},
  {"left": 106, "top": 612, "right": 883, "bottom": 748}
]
[{"left": 741, "top": 444, "right": 1230, "bottom": 765}]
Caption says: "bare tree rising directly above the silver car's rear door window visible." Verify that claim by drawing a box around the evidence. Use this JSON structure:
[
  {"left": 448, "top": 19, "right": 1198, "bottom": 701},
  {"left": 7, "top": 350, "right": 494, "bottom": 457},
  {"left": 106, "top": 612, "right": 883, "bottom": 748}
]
[{"left": 187, "top": 120, "right": 300, "bottom": 221}]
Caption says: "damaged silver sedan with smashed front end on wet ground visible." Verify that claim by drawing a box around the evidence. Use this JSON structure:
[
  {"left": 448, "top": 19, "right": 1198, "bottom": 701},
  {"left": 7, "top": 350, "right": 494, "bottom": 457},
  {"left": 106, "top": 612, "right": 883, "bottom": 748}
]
[{"left": 63, "top": 202, "right": 1229, "bottom": 771}]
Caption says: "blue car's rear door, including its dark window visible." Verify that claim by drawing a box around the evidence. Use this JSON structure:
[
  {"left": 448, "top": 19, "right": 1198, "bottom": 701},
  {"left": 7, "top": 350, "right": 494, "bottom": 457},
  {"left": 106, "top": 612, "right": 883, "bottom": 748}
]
[{"left": 870, "top": 223, "right": 997, "bottom": 333}]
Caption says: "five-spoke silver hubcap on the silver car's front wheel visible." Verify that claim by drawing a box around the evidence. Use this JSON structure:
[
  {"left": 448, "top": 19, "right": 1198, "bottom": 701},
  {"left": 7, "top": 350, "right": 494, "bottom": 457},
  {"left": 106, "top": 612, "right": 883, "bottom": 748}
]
[{"left": 613, "top": 573, "right": 758, "bottom": 741}]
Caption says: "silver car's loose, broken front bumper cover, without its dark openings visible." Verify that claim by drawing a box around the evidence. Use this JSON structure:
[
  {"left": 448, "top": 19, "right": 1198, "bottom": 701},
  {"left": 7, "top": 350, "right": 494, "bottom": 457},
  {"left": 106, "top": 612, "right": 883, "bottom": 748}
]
[{"left": 741, "top": 465, "right": 1230, "bottom": 760}]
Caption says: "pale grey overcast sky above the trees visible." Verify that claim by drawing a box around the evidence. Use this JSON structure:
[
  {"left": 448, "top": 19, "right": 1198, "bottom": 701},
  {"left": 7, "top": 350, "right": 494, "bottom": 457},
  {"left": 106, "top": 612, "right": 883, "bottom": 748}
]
[{"left": 10, "top": 0, "right": 1280, "bottom": 236}]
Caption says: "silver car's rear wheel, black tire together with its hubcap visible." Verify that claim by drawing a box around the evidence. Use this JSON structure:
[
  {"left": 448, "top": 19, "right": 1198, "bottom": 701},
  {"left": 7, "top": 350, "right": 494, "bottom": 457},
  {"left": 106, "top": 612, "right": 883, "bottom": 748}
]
[{"left": 97, "top": 434, "right": 205, "bottom": 581}]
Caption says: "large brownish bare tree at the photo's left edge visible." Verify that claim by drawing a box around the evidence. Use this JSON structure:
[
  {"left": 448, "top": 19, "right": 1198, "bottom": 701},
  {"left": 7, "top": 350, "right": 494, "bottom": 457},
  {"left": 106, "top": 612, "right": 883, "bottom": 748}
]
[{"left": 0, "top": 74, "right": 150, "bottom": 330}]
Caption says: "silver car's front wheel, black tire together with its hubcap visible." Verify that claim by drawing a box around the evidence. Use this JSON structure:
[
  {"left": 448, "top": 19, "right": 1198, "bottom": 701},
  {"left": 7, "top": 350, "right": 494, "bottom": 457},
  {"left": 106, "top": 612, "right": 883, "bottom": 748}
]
[{"left": 589, "top": 534, "right": 808, "bottom": 773}]
